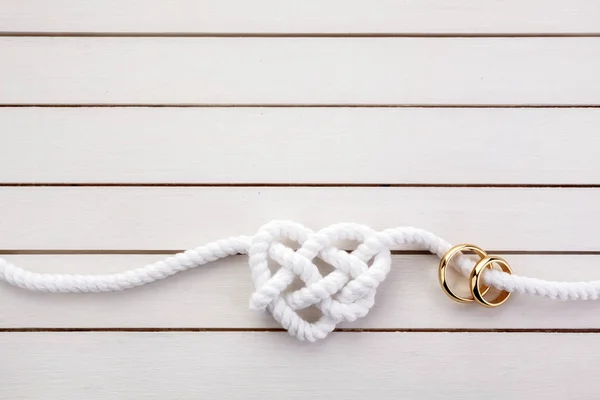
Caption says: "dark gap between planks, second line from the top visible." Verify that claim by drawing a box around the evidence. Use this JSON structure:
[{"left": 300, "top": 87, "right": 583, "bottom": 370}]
[{"left": 5, "top": 103, "right": 600, "bottom": 108}]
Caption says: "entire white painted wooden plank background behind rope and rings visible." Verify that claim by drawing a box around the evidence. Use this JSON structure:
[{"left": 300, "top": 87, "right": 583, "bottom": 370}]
[{"left": 0, "top": 0, "right": 600, "bottom": 400}]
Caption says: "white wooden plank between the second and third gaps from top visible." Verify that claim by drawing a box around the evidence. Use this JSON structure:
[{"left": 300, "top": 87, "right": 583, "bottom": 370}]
[{"left": 0, "top": 107, "right": 600, "bottom": 184}]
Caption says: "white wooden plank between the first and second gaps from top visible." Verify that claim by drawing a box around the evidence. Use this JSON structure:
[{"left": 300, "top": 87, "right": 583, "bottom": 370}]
[{"left": 0, "top": 37, "right": 600, "bottom": 105}]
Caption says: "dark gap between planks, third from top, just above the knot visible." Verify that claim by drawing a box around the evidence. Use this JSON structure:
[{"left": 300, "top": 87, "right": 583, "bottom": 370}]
[{"left": 0, "top": 182, "right": 600, "bottom": 189}]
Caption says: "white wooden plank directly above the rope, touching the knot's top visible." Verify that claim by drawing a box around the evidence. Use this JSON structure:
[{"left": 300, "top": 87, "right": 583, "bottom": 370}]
[{"left": 0, "top": 187, "right": 600, "bottom": 251}]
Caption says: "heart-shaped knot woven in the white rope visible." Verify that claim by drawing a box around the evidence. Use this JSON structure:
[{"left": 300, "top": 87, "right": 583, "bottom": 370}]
[{"left": 249, "top": 221, "right": 392, "bottom": 342}]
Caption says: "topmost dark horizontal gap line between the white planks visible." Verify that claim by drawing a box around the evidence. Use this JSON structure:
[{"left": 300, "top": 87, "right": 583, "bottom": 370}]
[{"left": 0, "top": 31, "right": 600, "bottom": 39}]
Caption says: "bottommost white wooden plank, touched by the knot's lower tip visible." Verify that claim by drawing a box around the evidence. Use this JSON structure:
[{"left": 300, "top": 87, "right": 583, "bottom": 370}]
[{"left": 0, "top": 332, "right": 600, "bottom": 400}]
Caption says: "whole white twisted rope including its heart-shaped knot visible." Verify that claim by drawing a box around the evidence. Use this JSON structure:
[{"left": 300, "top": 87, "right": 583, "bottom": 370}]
[{"left": 0, "top": 221, "right": 600, "bottom": 341}]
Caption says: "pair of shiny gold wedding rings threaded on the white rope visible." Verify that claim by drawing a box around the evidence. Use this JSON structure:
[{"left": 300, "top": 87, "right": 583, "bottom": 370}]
[{"left": 438, "top": 244, "right": 512, "bottom": 308}]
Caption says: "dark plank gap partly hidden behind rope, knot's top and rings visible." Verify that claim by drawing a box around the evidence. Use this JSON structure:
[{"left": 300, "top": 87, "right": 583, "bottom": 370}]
[{"left": 0, "top": 249, "right": 600, "bottom": 256}]
